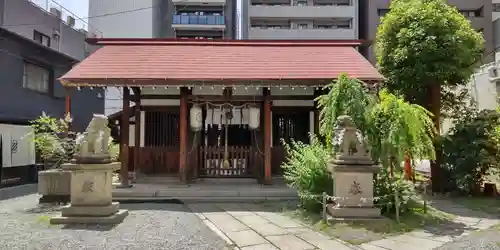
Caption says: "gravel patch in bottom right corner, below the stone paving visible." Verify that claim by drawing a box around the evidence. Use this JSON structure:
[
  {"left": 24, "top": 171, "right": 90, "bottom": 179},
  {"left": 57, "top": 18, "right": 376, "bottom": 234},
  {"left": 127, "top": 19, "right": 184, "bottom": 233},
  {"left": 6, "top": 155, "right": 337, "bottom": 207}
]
[{"left": 435, "top": 229, "right": 500, "bottom": 250}]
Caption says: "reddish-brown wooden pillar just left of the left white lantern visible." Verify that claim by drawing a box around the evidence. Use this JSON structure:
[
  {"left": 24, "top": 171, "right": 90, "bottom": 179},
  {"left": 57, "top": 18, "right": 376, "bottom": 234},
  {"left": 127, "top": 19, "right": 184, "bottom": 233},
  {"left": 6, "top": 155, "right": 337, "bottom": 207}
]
[{"left": 179, "top": 87, "right": 188, "bottom": 184}]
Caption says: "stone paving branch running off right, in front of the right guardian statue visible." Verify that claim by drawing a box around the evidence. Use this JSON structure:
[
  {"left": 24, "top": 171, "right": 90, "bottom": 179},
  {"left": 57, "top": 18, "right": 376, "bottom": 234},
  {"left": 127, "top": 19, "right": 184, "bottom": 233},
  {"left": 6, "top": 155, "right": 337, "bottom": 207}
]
[{"left": 360, "top": 199, "right": 500, "bottom": 250}]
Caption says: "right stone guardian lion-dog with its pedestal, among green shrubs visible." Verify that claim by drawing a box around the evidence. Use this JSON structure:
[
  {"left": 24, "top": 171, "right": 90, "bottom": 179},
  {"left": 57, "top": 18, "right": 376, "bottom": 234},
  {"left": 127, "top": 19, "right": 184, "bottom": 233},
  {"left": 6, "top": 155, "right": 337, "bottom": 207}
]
[{"left": 327, "top": 116, "right": 381, "bottom": 219}]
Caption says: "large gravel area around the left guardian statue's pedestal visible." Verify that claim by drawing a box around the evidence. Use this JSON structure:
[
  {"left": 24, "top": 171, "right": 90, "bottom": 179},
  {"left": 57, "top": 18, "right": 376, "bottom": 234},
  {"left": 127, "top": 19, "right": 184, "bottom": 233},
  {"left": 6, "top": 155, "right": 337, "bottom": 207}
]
[{"left": 0, "top": 194, "right": 228, "bottom": 250}]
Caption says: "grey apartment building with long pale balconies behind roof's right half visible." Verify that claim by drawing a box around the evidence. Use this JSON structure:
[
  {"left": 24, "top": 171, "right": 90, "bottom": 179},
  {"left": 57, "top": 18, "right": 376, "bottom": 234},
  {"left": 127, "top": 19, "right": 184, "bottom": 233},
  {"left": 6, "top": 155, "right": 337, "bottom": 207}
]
[{"left": 241, "top": 0, "right": 359, "bottom": 40}]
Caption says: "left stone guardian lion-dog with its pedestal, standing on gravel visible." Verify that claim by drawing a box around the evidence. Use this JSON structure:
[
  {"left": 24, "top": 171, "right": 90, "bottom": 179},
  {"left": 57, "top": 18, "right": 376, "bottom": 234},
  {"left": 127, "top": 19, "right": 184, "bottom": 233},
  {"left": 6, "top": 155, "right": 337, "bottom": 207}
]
[{"left": 50, "top": 115, "right": 128, "bottom": 224}]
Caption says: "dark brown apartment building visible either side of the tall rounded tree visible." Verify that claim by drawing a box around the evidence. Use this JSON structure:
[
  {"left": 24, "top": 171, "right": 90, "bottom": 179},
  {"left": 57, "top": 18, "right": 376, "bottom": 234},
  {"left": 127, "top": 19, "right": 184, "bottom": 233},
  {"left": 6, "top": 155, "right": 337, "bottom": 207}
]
[{"left": 360, "top": 0, "right": 495, "bottom": 63}]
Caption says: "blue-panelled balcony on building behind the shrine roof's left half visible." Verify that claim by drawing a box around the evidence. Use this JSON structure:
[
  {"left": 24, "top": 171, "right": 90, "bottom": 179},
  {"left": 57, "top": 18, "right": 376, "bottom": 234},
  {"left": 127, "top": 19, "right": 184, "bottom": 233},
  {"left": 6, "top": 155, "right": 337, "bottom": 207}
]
[{"left": 172, "top": 15, "right": 226, "bottom": 30}]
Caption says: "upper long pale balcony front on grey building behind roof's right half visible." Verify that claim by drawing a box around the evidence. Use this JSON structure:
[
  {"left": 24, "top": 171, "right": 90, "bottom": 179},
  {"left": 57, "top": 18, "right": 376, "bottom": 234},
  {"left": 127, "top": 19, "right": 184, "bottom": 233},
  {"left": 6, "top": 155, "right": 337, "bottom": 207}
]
[{"left": 248, "top": 5, "right": 357, "bottom": 19}]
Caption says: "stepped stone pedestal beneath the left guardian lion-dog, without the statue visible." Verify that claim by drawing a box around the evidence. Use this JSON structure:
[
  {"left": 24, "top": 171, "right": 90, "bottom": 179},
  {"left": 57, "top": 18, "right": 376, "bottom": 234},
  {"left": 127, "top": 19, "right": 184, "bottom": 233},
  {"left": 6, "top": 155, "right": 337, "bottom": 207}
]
[{"left": 50, "top": 162, "right": 128, "bottom": 224}]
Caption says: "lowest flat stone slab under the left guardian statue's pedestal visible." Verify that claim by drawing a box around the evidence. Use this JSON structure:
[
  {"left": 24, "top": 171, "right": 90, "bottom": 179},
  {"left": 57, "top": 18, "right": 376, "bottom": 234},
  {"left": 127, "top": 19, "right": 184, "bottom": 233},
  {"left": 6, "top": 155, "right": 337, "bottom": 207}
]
[{"left": 50, "top": 209, "right": 128, "bottom": 225}]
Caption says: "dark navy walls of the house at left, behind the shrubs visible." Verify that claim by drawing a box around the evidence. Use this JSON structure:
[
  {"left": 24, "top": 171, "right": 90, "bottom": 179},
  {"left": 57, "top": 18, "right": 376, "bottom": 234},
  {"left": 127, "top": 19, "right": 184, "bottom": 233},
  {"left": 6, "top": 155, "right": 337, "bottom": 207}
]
[{"left": 0, "top": 31, "right": 104, "bottom": 130}]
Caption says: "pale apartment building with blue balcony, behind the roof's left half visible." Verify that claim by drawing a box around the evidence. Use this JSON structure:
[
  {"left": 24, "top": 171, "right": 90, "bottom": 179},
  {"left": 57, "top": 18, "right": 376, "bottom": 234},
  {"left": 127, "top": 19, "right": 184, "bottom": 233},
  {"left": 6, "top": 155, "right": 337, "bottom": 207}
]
[{"left": 89, "top": 0, "right": 237, "bottom": 114}]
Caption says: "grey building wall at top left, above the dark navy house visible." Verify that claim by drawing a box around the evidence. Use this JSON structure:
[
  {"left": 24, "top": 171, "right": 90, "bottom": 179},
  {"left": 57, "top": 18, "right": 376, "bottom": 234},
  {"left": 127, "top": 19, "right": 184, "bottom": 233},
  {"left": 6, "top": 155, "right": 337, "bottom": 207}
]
[{"left": 0, "top": 0, "right": 86, "bottom": 60}]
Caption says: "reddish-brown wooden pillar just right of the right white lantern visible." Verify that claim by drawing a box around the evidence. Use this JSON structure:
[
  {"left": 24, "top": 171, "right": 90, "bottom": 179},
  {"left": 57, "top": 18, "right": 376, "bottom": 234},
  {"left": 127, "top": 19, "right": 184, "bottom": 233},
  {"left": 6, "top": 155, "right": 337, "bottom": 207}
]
[{"left": 263, "top": 88, "right": 272, "bottom": 185}]
